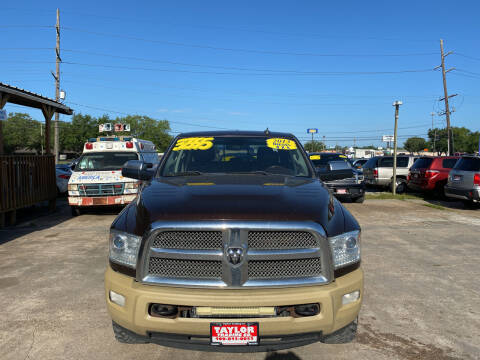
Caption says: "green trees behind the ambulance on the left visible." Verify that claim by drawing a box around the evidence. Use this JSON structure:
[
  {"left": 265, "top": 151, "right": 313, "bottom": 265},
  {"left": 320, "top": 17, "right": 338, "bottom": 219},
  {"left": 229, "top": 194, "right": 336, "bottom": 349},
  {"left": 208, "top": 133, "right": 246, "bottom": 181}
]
[{"left": 3, "top": 113, "right": 172, "bottom": 154}]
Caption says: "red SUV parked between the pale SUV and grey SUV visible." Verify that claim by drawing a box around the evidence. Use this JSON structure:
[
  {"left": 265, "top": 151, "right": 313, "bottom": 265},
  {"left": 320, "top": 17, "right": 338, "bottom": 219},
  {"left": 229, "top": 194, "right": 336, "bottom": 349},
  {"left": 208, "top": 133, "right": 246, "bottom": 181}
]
[{"left": 407, "top": 156, "right": 460, "bottom": 195}]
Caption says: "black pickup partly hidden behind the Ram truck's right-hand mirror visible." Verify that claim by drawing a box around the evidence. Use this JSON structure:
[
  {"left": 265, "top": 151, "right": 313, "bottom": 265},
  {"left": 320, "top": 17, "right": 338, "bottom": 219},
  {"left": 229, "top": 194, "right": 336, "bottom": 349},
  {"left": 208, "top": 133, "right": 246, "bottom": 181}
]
[{"left": 310, "top": 153, "right": 365, "bottom": 203}]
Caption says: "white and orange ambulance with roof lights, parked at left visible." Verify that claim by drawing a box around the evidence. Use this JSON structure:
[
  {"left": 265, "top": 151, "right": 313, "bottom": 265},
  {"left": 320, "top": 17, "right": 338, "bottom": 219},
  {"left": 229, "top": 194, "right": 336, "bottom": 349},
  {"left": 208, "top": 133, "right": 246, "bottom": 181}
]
[{"left": 68, "top": 136, "right": 159, "bottom": 216}]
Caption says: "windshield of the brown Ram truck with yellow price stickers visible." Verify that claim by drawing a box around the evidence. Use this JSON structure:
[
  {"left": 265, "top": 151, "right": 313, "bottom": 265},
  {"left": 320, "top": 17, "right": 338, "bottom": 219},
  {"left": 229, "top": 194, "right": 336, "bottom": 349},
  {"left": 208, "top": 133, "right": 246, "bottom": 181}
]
[{"left": 161, "top": 136, "right": 312, "bottom": 177}]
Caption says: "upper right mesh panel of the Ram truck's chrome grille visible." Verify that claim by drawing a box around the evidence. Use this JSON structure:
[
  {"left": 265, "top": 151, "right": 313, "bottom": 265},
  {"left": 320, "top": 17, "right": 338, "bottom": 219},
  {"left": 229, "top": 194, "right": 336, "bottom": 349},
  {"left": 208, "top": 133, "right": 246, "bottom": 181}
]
[{"left": 248, "top": 231, "right": 318, "bottom": 250}]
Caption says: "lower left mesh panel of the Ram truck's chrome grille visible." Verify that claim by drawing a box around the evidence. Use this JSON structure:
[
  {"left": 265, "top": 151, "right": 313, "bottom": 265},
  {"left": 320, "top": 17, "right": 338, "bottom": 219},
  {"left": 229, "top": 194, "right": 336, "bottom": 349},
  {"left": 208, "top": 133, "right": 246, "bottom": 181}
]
[{"left": 148, "top": 258, "right": 222, "bottom": 279}]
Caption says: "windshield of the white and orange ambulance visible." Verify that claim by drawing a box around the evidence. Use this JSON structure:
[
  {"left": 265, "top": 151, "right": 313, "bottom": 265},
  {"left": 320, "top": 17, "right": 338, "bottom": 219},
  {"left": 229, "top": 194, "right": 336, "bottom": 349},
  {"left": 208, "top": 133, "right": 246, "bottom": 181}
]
[{"left": 75, "top": 152, "right": 138, "bottom": 171}]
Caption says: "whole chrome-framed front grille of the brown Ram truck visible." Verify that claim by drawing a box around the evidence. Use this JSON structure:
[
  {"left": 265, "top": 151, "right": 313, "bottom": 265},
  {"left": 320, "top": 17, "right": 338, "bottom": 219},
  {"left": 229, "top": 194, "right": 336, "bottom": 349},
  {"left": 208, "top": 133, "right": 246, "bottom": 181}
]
[{"left": 141, "top": 221, "right": 333, "bottom": 288}]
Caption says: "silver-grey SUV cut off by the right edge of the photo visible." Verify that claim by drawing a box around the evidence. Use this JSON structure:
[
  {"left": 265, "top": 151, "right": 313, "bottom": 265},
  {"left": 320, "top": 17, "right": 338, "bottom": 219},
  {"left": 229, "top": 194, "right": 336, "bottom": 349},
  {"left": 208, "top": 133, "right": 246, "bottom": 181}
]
[{"left": 445, "top": 155, "right": 480, "bottom": 206}]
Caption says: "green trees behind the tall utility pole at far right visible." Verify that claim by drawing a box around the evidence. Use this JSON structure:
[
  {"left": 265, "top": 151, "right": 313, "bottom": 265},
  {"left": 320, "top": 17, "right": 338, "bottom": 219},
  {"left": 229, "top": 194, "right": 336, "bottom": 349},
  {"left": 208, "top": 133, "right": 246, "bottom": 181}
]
[{"left": 428, "top": 127, "right": 480, "bottom": 154}]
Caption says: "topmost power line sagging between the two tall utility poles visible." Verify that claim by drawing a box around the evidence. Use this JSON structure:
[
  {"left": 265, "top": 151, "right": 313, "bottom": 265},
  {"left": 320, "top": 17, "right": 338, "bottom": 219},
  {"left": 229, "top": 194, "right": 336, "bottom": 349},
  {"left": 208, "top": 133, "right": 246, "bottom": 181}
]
[{"left": 62, "top": 27, "right": 435, "bottom": 57}]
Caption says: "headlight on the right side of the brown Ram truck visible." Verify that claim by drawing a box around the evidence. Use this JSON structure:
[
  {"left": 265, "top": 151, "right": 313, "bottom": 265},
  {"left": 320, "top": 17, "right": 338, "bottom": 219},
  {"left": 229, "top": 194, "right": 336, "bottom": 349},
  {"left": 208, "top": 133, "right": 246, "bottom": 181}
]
[{"left": 328, "top": 230, "right": 360, "bottom": 269}]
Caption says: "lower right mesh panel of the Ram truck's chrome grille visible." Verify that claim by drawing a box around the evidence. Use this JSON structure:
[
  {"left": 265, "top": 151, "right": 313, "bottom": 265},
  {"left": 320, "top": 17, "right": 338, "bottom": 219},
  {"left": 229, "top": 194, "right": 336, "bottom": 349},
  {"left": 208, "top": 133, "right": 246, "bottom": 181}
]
[{"left": 248, "top": 258, "right": 322, "bottom": 279}]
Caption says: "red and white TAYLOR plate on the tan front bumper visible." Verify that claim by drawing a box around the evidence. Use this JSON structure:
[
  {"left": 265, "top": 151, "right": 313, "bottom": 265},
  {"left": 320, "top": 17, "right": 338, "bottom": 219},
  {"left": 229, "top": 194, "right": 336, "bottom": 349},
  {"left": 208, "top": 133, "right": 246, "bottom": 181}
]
[{"left": 210, "top": 323, "right": 258, "bottom": 345}]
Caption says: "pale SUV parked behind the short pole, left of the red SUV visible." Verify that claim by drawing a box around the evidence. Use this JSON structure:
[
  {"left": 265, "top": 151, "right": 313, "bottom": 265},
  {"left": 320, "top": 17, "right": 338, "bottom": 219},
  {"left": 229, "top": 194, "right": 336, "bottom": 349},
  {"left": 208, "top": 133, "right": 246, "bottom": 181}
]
[{"left": 363, "top": 155, "right": 418, "bottom": 194}]
